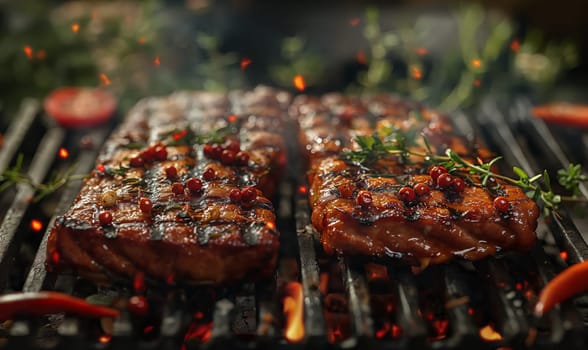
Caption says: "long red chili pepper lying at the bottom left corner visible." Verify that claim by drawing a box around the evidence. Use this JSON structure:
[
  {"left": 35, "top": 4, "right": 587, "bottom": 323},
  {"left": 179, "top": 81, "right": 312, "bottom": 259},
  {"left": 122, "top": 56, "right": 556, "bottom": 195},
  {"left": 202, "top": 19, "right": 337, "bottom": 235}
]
[{"left": 0, "top": 292, "right": 119, "bottom": 321}]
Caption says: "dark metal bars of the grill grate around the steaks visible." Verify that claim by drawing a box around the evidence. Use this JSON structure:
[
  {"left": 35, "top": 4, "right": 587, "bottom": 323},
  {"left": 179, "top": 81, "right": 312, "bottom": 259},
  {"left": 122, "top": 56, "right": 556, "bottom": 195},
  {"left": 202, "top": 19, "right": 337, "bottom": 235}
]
[{"left": 0, "top": 94, "right": 588, "bottom": 349}]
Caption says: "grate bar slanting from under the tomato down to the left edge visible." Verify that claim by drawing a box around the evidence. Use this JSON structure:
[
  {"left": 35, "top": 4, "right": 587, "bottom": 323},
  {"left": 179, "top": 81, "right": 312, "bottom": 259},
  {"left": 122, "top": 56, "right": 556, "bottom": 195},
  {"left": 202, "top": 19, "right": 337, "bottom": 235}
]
[{"left": 0, "top": 128, "right": 65, "bottom": 288}]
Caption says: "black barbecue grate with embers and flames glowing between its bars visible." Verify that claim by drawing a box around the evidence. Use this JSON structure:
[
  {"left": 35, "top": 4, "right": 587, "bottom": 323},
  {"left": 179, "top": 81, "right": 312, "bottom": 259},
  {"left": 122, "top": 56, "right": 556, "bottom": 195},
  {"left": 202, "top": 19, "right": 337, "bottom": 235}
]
[{"left": 0, "top": 99, "right": 588, "bottom": 349}]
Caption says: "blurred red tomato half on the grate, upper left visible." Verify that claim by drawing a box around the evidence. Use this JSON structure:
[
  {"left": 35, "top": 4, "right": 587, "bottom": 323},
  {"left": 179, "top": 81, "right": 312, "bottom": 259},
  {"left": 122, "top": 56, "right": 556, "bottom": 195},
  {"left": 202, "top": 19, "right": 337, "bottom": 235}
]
[{"left": 44, "top": 87, "right": 117, "bottom": 128}]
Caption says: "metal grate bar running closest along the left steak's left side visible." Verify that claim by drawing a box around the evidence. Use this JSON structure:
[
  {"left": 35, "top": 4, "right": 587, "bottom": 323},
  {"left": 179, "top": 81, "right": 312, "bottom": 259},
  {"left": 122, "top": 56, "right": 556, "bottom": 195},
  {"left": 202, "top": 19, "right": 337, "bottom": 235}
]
[{"left": 23, "top": 127, "right": 109, "bottom": 292}]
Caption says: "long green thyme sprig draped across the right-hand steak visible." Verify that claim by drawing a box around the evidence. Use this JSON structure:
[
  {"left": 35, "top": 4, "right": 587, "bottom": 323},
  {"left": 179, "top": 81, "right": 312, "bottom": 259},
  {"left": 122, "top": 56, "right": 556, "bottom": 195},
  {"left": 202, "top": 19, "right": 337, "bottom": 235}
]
[{"left": 342, "top": 130, "right": 588, "bottom": 215}]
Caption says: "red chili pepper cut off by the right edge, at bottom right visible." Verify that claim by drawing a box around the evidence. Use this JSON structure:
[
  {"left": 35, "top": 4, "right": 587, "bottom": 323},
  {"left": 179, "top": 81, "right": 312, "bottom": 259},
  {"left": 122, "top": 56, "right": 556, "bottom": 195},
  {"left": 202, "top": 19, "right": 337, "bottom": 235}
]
[{"left": 534, "top": 261, "right": 588, "bottom": 317}]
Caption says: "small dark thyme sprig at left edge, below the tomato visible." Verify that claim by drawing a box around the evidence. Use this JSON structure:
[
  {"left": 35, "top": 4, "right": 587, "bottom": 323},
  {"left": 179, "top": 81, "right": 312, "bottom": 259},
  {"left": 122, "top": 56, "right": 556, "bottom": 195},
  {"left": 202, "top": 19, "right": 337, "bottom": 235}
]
[{"left": 0, "top": 154, "right": 86, "bottom": 202}]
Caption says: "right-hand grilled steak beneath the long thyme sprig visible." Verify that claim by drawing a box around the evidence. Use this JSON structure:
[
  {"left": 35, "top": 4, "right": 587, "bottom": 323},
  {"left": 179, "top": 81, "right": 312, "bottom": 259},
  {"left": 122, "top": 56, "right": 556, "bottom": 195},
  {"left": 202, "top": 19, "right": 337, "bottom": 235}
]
[{"left": 290, "top": 94, "right": 538, "bottom": 264}]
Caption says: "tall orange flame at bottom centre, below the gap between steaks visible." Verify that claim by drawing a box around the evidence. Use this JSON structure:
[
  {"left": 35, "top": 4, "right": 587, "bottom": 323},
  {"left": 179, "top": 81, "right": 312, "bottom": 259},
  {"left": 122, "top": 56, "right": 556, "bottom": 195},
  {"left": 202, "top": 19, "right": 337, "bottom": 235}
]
[{"left": 283, "top": 282, "right": 304, "bottom": 343}]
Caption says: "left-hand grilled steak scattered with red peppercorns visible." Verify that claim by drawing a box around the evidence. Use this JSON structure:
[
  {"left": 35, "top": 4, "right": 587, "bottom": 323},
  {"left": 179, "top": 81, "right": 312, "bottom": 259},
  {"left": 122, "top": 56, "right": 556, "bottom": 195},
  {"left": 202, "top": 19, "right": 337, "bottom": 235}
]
[{"left": 47, "top": 88, "right": 290, "bottom": 284}]
